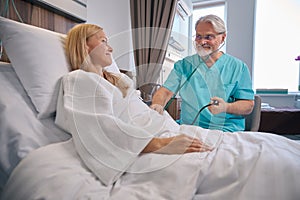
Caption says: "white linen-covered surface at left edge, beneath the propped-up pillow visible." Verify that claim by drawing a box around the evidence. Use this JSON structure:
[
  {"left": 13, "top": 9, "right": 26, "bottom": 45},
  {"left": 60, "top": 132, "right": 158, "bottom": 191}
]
[{"left": 0, "top": 62, "right": 70, "bottom": 192}]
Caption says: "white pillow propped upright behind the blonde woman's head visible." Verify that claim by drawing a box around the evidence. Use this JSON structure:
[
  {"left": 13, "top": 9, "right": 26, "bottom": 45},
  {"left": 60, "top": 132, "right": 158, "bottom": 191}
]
[{"left": 0, "top": 17, "right": 119, "bottom": 119}]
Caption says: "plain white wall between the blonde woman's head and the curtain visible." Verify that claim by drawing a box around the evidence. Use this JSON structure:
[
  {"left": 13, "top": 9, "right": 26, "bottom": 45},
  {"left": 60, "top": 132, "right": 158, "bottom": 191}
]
[{"left": 87, "top": 0, "right": 135, "bottom": 71}]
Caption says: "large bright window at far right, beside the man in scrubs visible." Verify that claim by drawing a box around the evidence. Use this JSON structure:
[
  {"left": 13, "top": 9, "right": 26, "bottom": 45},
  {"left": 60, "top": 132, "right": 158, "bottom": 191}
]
[{"left": 253, "top": 0, "right": 300, "bottom": 92}]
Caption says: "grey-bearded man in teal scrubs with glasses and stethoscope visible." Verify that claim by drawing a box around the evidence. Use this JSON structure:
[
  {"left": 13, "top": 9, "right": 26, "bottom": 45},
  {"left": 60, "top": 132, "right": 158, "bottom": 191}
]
[{"left": 150, "top": 15, "right": 254, "bottom": 132}]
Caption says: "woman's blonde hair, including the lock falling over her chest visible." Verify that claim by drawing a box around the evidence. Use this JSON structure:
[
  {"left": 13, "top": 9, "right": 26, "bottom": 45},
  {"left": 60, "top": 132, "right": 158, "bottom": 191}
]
[{"left": 65, "top": 24, "right": 128, "bottom": 95}]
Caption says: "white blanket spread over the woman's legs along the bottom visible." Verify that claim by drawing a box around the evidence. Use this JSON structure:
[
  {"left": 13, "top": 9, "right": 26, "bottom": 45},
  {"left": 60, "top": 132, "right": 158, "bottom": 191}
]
[{"left": 2, "top": 130, "right": 300, "bottom": 200}]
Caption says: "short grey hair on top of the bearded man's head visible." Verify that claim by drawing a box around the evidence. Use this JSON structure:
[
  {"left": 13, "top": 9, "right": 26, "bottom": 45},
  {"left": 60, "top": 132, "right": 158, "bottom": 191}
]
[{"left": 195, "top": 15, "right": 226, "bottom": 33}]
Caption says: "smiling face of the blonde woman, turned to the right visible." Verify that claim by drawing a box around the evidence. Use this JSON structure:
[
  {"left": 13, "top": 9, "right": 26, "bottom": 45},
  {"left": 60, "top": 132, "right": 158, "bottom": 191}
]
[{"left": 87, "top": 30, "right": 113, "bottom": 67}]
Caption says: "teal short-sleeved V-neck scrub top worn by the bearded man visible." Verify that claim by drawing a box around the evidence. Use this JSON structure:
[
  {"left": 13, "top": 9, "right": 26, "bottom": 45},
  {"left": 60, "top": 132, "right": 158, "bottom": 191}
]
[{"left": 163, "top": 54, "right": 254, "bottom": 132}]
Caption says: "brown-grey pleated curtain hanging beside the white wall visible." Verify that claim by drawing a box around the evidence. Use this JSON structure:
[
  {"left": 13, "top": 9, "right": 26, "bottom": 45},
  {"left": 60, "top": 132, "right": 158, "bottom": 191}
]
[{"left": 130, "top": 0, "right": 177, "bottom": 88}]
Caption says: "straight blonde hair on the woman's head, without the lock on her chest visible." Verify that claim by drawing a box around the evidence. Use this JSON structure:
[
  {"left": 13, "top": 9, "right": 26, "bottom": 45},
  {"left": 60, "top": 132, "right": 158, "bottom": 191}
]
[{"left": 65, "top": 24, "right": 103, "bottom": 70}]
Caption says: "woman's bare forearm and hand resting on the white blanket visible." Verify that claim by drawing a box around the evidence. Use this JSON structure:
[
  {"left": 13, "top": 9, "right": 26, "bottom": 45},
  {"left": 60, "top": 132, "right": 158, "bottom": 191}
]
[{"left": 142, "top": 134, "right": 212, "bottom": 154}]
